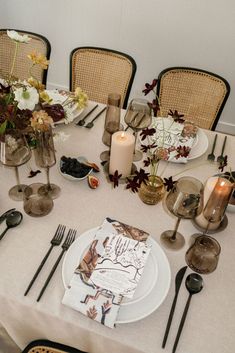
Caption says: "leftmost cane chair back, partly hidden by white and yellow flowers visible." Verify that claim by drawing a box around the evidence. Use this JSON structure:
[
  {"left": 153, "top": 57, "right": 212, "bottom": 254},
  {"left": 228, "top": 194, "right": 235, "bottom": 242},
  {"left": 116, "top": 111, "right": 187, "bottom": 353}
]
[{"left": 0, "top": 29, "right": 51, "bottom": 84}]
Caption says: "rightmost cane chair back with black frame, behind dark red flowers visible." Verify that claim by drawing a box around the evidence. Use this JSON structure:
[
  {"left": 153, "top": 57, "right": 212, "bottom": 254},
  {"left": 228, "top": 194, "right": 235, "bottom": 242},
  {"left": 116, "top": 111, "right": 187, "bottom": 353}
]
[{"left": 157, "top": 67, "right": 230, "bottom": 130}]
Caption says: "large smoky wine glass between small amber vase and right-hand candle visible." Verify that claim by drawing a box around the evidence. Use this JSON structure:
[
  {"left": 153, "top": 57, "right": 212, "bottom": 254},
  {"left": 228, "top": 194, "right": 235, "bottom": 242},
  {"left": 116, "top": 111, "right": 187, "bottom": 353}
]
[{"left": 161, "top": 177, "right": 203, "bottom": 250}]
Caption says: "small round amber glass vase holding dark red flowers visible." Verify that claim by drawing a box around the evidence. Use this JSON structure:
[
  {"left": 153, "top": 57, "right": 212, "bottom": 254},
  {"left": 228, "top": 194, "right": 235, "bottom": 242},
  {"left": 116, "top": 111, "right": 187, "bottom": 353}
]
[{"left": 138, "top": 175, "right": 165, "bottom": 205}]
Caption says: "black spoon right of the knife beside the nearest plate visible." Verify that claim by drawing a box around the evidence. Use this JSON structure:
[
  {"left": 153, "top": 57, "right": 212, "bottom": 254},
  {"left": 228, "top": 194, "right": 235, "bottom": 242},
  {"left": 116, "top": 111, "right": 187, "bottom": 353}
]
[{"left": 172, "top": 273, "right": 203, "bottom": 353}]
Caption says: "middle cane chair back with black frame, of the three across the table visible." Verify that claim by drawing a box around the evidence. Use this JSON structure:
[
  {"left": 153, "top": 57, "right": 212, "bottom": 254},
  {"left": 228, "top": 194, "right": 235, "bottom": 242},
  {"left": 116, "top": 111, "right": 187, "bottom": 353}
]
[{"left": 70, "top": 47, "right": 136, "bottom": 108}]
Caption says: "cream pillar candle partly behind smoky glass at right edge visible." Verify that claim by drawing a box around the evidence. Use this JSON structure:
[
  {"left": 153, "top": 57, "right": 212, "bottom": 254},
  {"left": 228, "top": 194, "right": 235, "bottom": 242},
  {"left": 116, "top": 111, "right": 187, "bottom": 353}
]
[{"left": 195, "top": 177, "right": 220, "bottom": 230}]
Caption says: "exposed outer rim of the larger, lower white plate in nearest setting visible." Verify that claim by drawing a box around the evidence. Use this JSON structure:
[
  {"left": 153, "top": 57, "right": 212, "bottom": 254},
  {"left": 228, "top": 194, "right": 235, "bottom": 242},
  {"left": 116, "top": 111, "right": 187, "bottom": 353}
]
[{"left": 62, "top": 227, "right": 171, "bottom": 324}]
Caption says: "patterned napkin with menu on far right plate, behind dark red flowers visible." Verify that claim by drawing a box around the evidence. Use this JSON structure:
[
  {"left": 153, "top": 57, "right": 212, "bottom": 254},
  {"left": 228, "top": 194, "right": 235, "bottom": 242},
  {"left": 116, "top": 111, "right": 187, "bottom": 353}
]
[{"left": 151, "top": 116, "right": 198, "bottom": 163}]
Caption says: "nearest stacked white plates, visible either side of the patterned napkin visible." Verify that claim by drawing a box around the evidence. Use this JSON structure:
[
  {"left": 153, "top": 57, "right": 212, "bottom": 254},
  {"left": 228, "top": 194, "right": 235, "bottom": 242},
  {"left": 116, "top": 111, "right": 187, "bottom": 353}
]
[{"left": 62, "top": 228, "right": 171, "bottom": 324}]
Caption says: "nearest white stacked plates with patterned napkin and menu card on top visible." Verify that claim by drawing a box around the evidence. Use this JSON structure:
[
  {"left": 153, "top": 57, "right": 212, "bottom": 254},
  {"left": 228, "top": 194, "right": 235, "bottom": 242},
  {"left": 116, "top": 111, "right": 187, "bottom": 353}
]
[{"left": 62, "top": 218, "right": 171, "bottom": 327}]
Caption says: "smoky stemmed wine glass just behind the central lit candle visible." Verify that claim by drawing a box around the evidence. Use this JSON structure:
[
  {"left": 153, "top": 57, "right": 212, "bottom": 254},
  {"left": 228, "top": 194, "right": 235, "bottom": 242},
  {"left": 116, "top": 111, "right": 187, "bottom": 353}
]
[{"left": 124, "top": 98, "right": 152, "bottom": 161}]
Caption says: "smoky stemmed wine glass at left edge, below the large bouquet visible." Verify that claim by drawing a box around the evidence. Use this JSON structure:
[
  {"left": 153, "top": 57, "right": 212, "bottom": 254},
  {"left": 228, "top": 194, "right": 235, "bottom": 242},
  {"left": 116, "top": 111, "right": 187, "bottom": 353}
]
[{"left": 0, "top": 129, "right": 31, "bottom": 201}]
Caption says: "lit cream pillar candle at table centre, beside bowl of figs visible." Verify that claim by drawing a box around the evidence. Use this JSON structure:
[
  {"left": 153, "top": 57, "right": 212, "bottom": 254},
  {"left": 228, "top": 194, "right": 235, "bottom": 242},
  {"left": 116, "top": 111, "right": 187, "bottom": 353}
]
[{"left": 109, "top": 131, "right": 135, "bottom": 178}]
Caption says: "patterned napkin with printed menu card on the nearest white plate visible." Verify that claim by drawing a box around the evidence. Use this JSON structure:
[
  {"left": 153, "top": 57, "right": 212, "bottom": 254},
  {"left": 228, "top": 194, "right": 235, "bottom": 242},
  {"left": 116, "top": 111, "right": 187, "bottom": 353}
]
[{"left": 62, "top": 218, "right": 150, "bottom": 328}]
